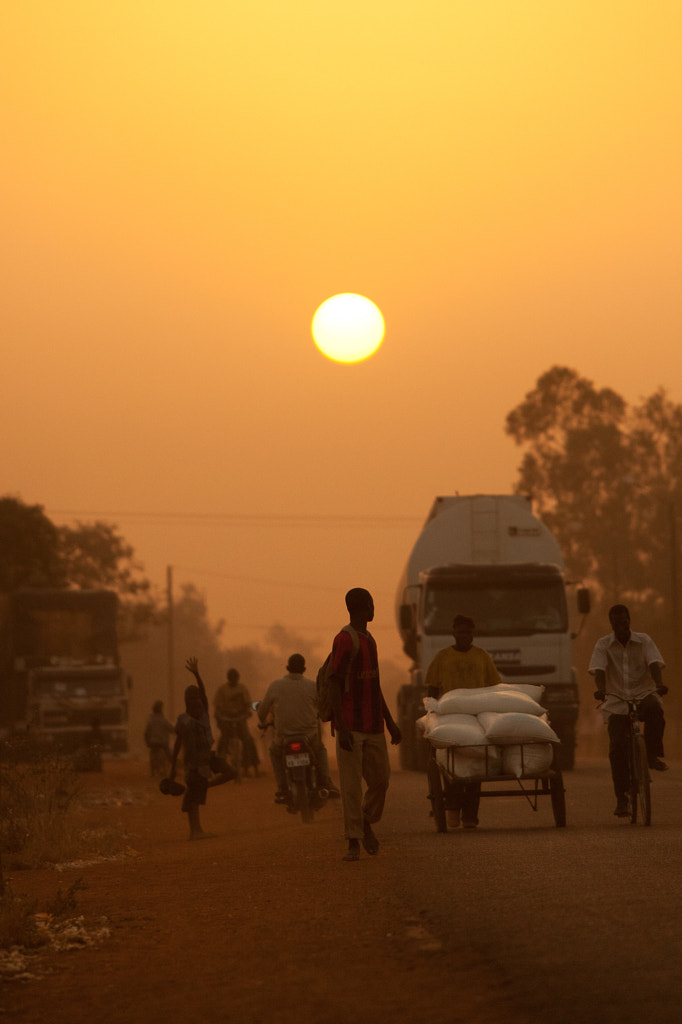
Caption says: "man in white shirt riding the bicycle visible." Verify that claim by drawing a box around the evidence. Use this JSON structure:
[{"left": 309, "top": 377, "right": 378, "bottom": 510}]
[{"left": 588, "top": 604, "right": 668, "bottom": 817}]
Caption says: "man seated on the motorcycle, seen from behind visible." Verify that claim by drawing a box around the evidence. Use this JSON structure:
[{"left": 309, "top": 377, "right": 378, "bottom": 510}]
[{"left": 258, "top": 654, "right": 339, "bottom": 803}]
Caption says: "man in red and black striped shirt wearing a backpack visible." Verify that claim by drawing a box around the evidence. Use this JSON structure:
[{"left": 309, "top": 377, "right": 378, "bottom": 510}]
[{"left": 329, "top": 587, "right": 400, "bottom": 861}]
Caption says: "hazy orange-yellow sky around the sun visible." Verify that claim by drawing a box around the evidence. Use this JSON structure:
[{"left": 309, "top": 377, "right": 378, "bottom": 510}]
[{"left": 0, "top": 0, "right": 682, "bottom": 653}]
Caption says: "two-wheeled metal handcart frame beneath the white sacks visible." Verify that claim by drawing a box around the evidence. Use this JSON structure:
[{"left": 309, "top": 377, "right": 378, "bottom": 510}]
[{"left": 427, "top": 743, "right": 566, "bottom": 833}]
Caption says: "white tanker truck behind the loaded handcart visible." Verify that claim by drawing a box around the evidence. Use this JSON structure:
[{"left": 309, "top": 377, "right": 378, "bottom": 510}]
[{"left": 395, "top": 495, "right": 590, "bottom": 770}]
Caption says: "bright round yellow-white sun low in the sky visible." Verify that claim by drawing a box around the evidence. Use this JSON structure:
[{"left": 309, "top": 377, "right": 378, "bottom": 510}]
[{"left": 312, "top": 292, "right": 385, "bottom": 362}]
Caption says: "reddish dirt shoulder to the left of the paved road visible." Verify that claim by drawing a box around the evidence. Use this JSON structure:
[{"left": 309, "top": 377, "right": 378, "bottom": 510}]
[{"left": 0, "top": 762, "right": 522, "bottom": 1024}]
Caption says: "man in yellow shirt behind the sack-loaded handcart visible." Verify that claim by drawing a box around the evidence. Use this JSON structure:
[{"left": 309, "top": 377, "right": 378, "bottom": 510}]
[{"left": 425, "top": 615, "right": 502, "bottom": 828}]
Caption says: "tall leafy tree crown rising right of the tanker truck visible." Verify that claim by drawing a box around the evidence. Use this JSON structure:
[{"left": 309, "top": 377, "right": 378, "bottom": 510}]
[{"left": 506, "top": 367, "right": 682, "bottom": 668}]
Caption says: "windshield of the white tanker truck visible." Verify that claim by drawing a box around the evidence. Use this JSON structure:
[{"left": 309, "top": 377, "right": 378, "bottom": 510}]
[{"left": 424, "top": 580, "right": 568, "bottom": 637}]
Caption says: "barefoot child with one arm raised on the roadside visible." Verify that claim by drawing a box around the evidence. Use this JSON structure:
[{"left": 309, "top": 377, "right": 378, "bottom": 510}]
[{"left": 169, "top": 657, "right": 235, "bottom": 840}]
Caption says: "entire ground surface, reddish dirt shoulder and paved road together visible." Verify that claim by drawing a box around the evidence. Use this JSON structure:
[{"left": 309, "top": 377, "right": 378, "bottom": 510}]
[{"left": 0, "top": 762, "right": 682, "bottom": 1024}]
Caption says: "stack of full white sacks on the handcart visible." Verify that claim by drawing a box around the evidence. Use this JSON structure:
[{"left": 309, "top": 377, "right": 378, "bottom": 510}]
[{"left": 418, "top": 683, "right": 559, "bottom": 778}]
